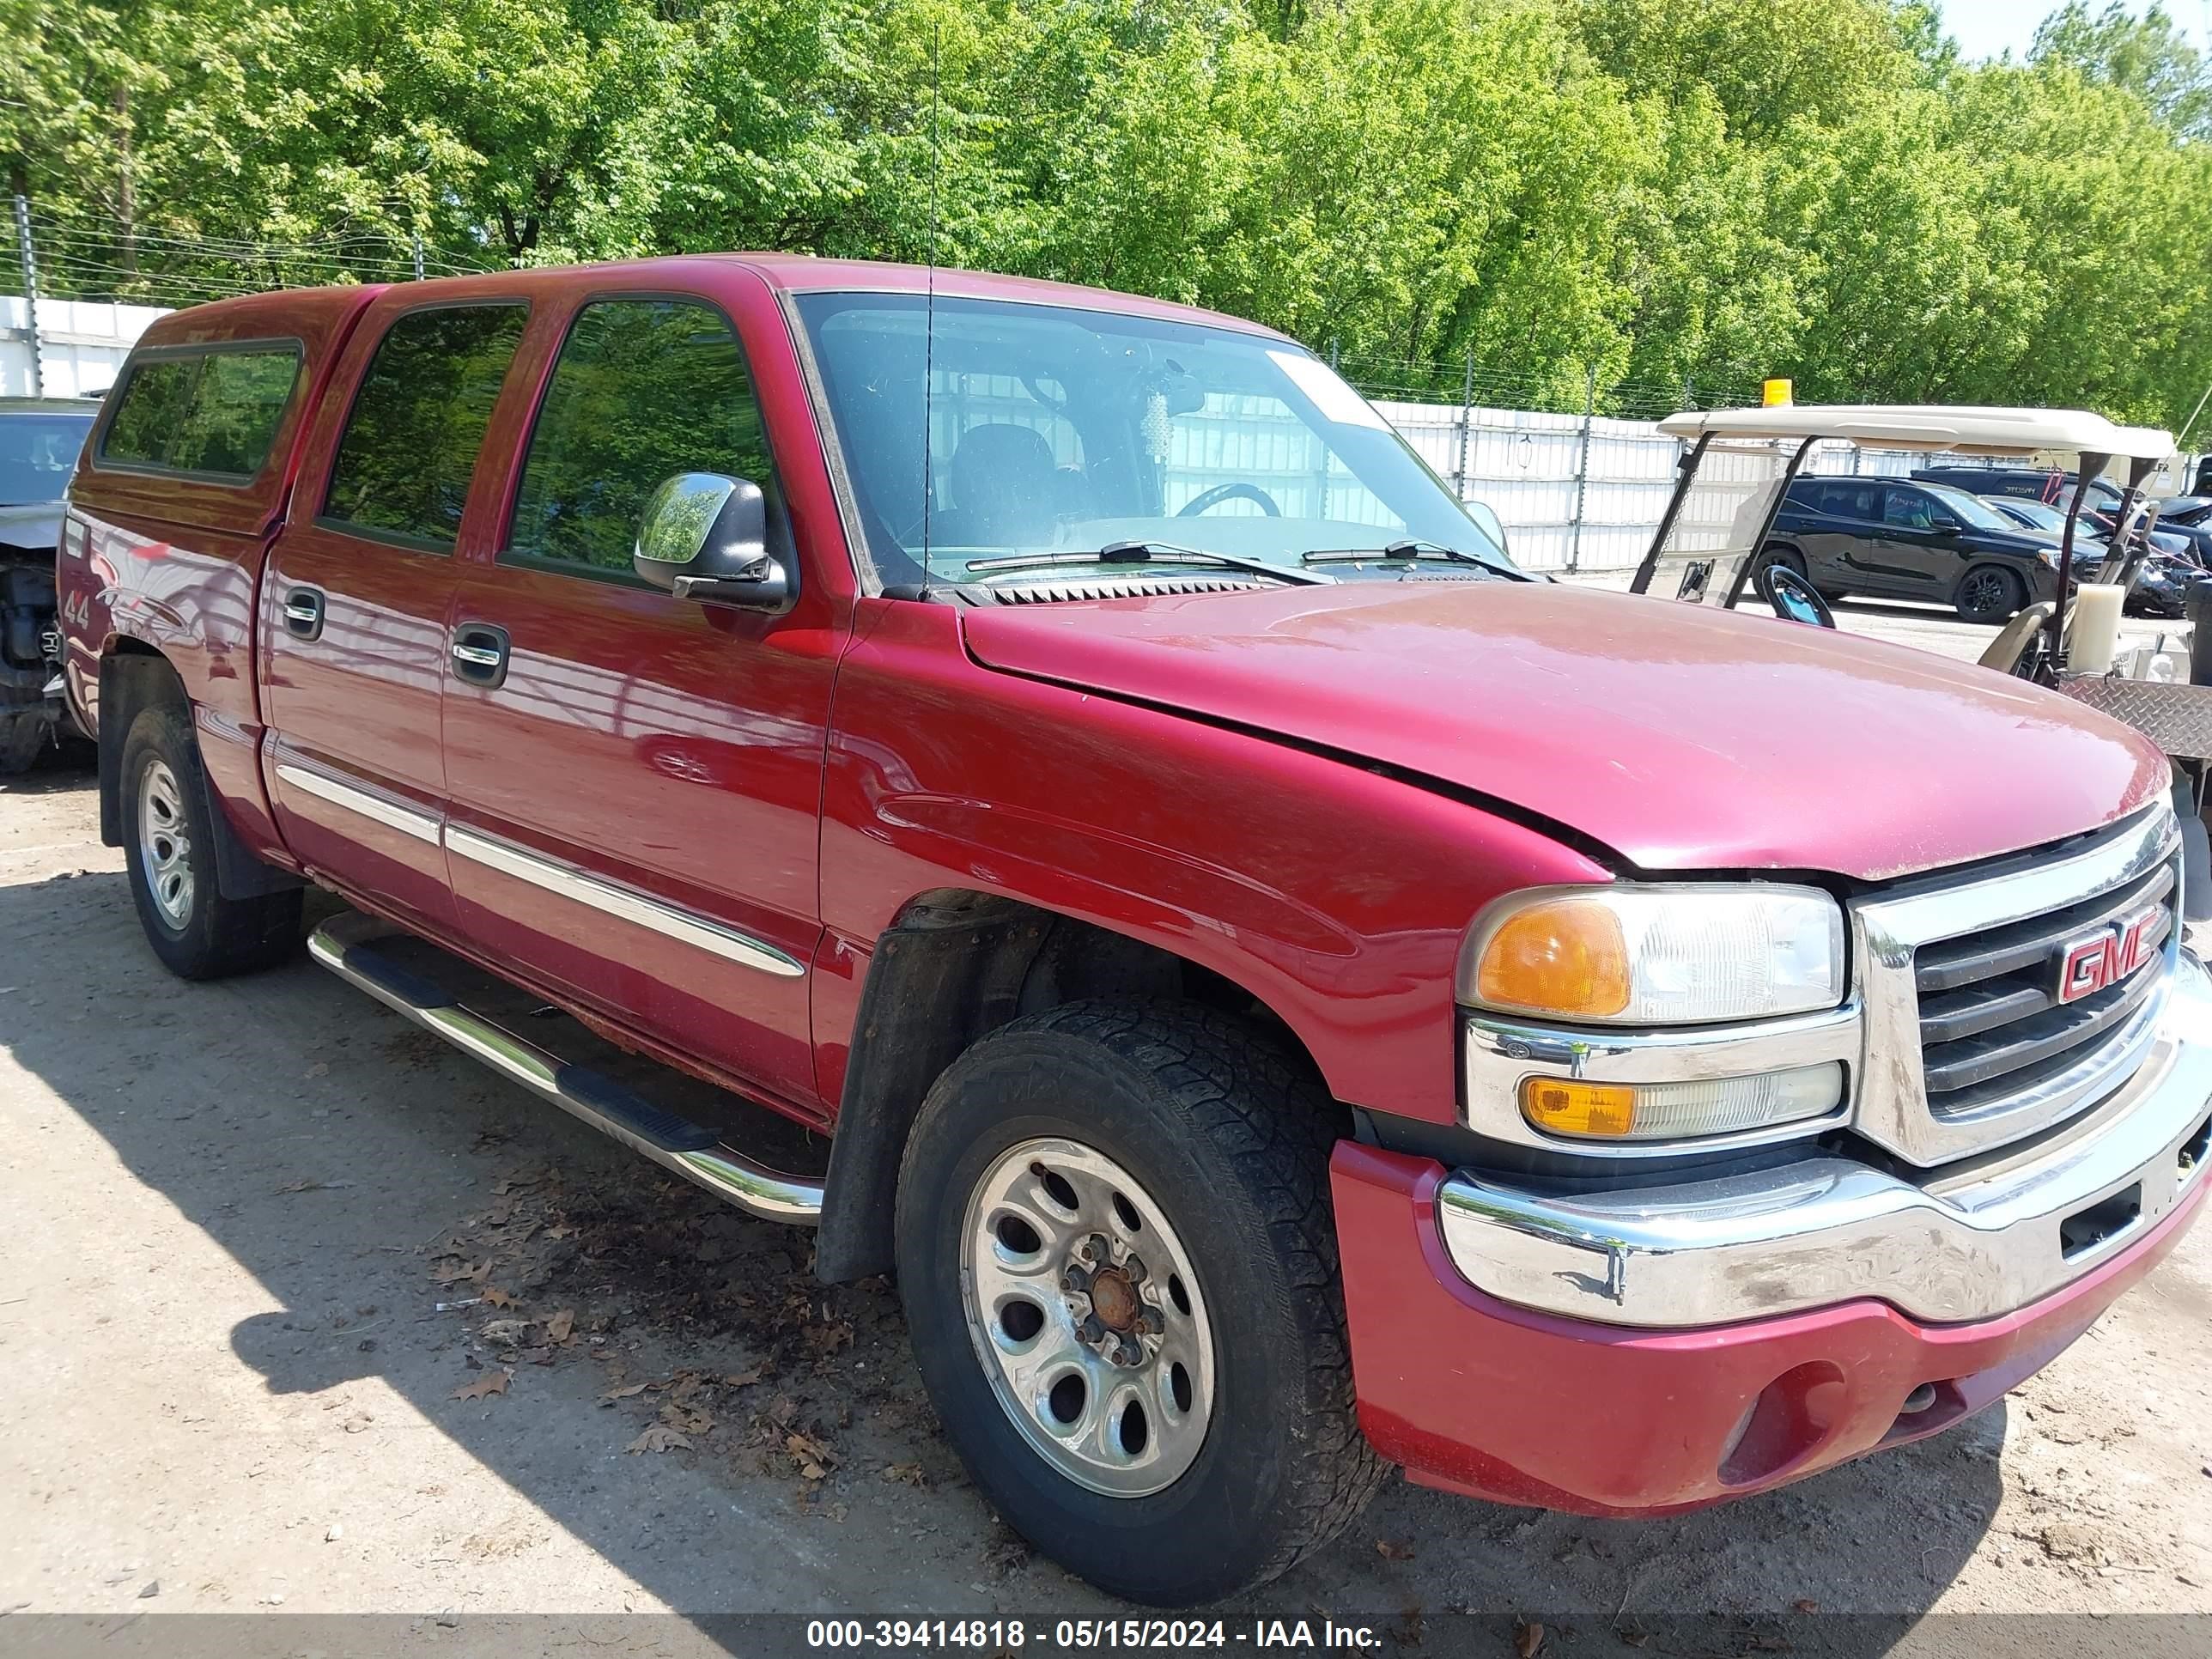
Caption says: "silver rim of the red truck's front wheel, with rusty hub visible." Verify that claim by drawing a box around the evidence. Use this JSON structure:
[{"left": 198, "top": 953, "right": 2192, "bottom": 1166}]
[{"left": 960, "top": 1137, "right": 1214, "bottom": 1498}]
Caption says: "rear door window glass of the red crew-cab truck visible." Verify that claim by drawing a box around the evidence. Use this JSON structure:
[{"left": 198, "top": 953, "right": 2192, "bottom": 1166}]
[{"left": 323, "top": 303, "right": 529, "bottom": 553}]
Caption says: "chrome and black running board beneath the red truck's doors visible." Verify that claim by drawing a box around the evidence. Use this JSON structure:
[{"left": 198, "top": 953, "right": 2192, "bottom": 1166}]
[{"left": 307, "top": 914, "right": 823, "bottom": 1228}]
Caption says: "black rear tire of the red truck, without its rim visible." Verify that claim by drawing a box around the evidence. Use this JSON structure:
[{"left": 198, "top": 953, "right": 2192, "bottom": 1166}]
[{"left": 119, "top": 703, "right": 301, "bottom": 980}]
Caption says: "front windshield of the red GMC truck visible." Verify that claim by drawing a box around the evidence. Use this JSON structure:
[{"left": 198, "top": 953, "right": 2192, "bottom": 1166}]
[{"left": 799, "top": 295, "right": 1506, "bottom": 584}]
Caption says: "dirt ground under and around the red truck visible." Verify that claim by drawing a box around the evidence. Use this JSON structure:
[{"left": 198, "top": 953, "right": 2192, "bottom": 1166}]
[{"left": 0, "top": 605, "right": 2212, "bottom": 1655}]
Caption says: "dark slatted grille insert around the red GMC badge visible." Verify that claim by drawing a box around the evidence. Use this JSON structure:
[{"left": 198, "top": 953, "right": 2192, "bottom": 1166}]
[{"left": 1913, "top": 865, "right": 2179, "bottom": 1119}]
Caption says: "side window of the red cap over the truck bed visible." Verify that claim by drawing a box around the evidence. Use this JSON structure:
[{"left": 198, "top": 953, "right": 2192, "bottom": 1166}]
[{"left": 100, "top": 345, "right": 299, "bottom": 480}]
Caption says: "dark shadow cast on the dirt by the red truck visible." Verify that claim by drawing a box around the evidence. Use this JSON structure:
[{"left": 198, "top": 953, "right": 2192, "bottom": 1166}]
[{"left": 0, "top": 775, "right": 2004, "bottom": 1652}]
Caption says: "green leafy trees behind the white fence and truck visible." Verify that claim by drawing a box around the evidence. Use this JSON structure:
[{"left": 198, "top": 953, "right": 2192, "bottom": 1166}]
[{"left": 0, "top": 0, "right": 2212, "bottom": 420}]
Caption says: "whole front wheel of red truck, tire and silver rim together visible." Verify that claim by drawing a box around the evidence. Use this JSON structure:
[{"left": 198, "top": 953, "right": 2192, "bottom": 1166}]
[{"left": 896, "top": 1000, "right": 1385, "bottom": 1606}]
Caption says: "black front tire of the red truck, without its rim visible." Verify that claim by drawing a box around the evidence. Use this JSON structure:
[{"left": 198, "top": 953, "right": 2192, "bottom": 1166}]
[{"left": 896, "top": 1000, "right": 1387, "bottom": 1606}]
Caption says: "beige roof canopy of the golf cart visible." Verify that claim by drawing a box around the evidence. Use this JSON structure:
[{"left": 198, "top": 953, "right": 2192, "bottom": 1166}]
[{"left": 1659, "top": 403, "right": 2174, "bottom": 460}]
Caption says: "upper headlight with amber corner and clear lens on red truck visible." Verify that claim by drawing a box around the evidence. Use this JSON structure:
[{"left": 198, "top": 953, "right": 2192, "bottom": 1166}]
[{"left": 1458, "top": 883, "right": 1844, "bottom": 1026}]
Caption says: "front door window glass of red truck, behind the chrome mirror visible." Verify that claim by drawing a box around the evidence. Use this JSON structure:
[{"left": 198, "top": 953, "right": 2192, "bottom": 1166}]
[{"left": 500, "top": 299, "right": 769, "bottom": 575}]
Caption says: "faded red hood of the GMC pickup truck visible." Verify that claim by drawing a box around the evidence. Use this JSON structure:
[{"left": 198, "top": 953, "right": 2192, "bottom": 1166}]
[{"left": 963, "top": 581, "right": 2167, "bottom": 880}]
